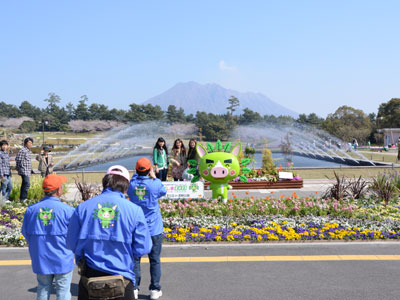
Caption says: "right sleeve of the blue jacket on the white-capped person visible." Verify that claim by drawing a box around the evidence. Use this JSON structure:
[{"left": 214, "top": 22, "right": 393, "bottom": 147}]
[{"left": 132, "top": 209, "right": 153, "bottom": 257}]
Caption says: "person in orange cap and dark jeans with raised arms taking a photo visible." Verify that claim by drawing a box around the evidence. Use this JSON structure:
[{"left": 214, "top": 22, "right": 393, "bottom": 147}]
[{"left": 128, "top": 157, "right": 167, "bottom": 299}]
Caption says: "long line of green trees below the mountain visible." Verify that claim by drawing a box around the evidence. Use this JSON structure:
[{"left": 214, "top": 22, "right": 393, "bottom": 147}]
[{"left": 0, "top": 93, "right": 400, "bottom": 143}]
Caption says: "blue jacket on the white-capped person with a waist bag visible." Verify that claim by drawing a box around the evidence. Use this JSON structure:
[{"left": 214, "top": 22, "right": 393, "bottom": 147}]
[{"left": 67, "top": 188, "right": 152, "bottom": 282}]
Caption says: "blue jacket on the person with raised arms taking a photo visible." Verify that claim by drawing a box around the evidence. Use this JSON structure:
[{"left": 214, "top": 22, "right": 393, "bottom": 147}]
[{"left": 127, "top": 174, "right": 167, "bottom": 236}]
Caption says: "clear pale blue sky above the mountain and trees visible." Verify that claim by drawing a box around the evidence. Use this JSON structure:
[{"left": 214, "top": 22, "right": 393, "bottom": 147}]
[{"left": 0, "top": 0, "right": 400, "bottom": 117}]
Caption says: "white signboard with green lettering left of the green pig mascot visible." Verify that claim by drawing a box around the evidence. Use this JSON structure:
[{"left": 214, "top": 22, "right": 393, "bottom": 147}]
[{"left": 162, "top": 181, "right": 204, "bottom": 199}]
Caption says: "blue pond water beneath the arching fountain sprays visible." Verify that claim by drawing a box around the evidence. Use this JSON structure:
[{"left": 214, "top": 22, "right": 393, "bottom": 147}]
[{"left": 75, "top": 152, "right": 340, "bottom": 171}]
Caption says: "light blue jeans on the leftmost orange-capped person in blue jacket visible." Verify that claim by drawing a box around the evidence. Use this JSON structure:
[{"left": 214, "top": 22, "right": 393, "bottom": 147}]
[{"left": 36, "top": 271, "right": 72, "bottom": 300}]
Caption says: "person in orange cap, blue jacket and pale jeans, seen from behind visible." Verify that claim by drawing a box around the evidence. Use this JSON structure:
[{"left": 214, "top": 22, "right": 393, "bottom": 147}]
[{"left": 22, "top": 174, "right": 74, "bottom": 300}]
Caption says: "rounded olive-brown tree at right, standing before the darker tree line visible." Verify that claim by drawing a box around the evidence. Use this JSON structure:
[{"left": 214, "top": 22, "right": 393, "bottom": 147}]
[{"left": 323, "top": 106, "right": 372, "bottom": 143}]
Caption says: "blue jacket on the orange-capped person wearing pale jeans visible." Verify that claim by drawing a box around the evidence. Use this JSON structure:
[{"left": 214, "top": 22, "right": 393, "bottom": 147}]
[{"left": 22, "top": 197, "right": 74, "bottom": 275}]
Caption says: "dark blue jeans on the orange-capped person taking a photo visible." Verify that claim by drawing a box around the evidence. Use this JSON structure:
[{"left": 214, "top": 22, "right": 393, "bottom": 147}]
[{"left": 133, "top": 233, "right": 164, "bottom": 291}]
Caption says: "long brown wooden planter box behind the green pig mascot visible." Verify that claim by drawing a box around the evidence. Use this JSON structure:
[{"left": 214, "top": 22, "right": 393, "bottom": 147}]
[{"left": 204, "top": 180, "right": 303, "bottom": 190}]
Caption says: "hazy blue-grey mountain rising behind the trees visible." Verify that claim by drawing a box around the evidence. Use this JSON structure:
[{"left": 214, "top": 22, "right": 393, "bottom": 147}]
[{"left": 144, "top": 81, "right": 298, "bottom": 117}]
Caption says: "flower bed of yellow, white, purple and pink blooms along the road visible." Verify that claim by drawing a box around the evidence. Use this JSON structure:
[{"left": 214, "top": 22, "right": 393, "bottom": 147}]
[{"left": 0, "top": 193, "right": 400, "bottom": 246}]
